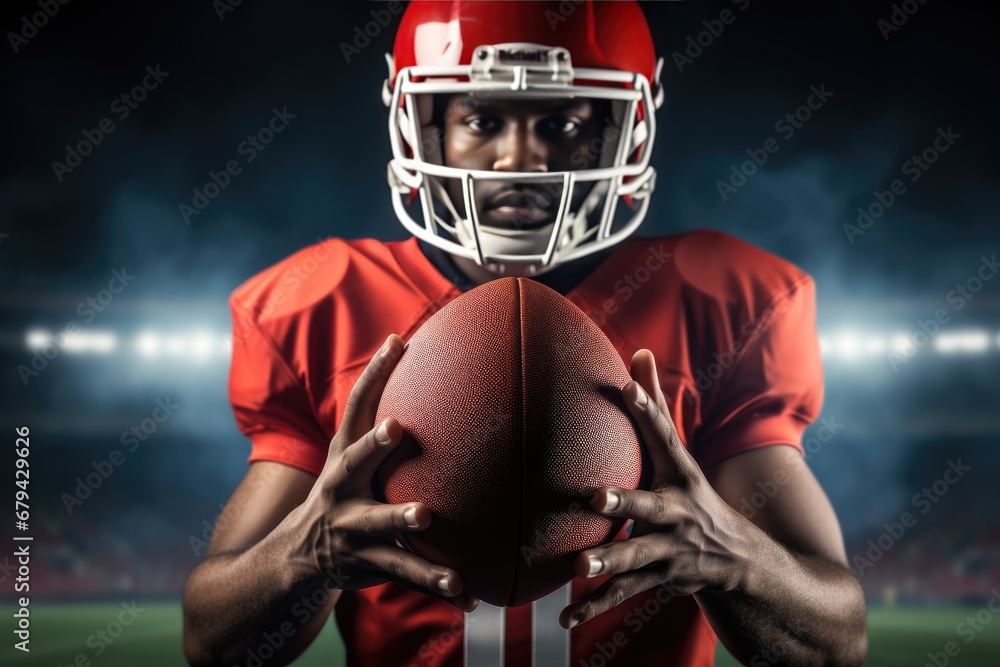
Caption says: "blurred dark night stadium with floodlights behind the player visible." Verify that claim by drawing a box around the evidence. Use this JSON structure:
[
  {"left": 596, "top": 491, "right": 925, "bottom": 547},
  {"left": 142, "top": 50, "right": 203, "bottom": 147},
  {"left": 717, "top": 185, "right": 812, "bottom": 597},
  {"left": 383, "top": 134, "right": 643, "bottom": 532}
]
[{"left": 0, "top": 0, "right": 1000, "bottom": 666}]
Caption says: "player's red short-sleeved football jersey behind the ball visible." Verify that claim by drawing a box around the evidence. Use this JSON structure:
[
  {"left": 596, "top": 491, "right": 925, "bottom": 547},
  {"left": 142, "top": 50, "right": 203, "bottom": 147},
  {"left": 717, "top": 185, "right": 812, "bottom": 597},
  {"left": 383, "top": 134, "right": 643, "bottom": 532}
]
[{"left": 229, "top": 231, "right": 823, "bottom": 667}]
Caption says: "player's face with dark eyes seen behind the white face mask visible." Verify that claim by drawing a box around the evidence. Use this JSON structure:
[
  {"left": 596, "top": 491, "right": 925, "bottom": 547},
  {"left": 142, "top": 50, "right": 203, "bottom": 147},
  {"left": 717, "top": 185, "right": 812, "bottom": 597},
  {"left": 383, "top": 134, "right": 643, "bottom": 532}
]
[{"left": 442, "top": 95, "right": 611, "bottom": 229}]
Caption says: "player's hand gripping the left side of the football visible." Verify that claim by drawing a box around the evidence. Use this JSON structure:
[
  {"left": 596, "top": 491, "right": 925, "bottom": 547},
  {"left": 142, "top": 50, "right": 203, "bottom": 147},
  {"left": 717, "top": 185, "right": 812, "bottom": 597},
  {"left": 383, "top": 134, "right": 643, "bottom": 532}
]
[{"left": 304, "top": 334, "right": 478, "bottom": 611}]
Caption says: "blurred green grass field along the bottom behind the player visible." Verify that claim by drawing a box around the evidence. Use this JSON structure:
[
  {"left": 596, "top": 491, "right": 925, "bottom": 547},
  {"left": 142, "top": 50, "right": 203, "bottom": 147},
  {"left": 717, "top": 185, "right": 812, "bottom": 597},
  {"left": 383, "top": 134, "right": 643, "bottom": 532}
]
[{"left": 0, "top": 603, "right": 1000, "bottom": 667}]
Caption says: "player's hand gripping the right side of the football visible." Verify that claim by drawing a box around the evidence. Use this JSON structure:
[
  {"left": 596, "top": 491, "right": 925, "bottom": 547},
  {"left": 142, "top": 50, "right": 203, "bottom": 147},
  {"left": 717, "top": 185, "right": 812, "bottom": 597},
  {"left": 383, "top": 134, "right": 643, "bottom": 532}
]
[{"left": 559, "top": 350, "right": 749, "bottom": 628}]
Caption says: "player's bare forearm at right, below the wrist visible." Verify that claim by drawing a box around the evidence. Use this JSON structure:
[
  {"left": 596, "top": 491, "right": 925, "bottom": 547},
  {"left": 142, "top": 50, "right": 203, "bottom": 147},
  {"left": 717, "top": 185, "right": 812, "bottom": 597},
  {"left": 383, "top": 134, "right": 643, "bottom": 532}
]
[{"left": 695, "top": 522, "right": 868, "bottom": 665}]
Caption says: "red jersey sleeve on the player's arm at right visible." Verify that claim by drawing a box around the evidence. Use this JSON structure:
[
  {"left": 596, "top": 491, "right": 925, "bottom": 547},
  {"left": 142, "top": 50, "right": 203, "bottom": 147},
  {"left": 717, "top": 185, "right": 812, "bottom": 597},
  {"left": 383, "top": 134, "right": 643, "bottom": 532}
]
[{"left": 694, "top": 276, "right": 823, "bottom": 467}]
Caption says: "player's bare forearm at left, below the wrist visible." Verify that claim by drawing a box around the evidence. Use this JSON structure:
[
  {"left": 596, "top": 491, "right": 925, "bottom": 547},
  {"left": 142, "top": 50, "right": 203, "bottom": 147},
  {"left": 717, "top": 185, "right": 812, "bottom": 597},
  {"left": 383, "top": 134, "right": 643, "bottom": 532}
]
[{"left": 184, "top": 508, "right": 340, "bottom": 667}]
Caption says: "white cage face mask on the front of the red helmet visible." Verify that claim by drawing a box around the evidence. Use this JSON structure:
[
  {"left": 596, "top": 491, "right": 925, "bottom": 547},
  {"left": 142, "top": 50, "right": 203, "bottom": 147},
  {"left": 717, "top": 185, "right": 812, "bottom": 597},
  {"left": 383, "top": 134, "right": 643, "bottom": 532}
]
[{"left": 383, "top": 43, "right": 662, "bottom": 276}]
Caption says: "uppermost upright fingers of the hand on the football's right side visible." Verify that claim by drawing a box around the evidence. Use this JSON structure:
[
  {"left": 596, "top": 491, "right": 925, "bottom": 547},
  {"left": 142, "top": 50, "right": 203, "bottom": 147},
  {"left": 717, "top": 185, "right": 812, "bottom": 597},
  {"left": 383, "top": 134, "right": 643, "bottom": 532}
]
[{"left": 622, "top": 350, "right": 700, "bottom": 489}]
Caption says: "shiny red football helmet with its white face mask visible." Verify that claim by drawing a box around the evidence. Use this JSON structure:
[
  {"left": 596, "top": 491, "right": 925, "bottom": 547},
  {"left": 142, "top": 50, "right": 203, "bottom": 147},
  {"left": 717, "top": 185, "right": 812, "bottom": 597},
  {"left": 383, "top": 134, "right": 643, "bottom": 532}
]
[{"left": 382, "top": 0, "right": 663, "bottom": 275}]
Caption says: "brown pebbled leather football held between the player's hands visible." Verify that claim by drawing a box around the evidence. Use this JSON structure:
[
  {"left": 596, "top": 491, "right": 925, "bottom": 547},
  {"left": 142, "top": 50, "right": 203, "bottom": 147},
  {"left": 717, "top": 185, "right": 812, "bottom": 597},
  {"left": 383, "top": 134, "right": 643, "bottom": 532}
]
[{"left": 376, "top": 278, "right": 648, "bottom": 606}]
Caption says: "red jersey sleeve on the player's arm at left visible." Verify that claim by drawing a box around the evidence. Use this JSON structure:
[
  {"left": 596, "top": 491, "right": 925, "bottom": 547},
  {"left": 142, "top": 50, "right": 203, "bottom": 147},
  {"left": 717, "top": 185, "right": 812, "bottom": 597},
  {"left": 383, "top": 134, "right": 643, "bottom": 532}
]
[{"left": 229, "top": 299, "right": 330, "bottom": 476}]
